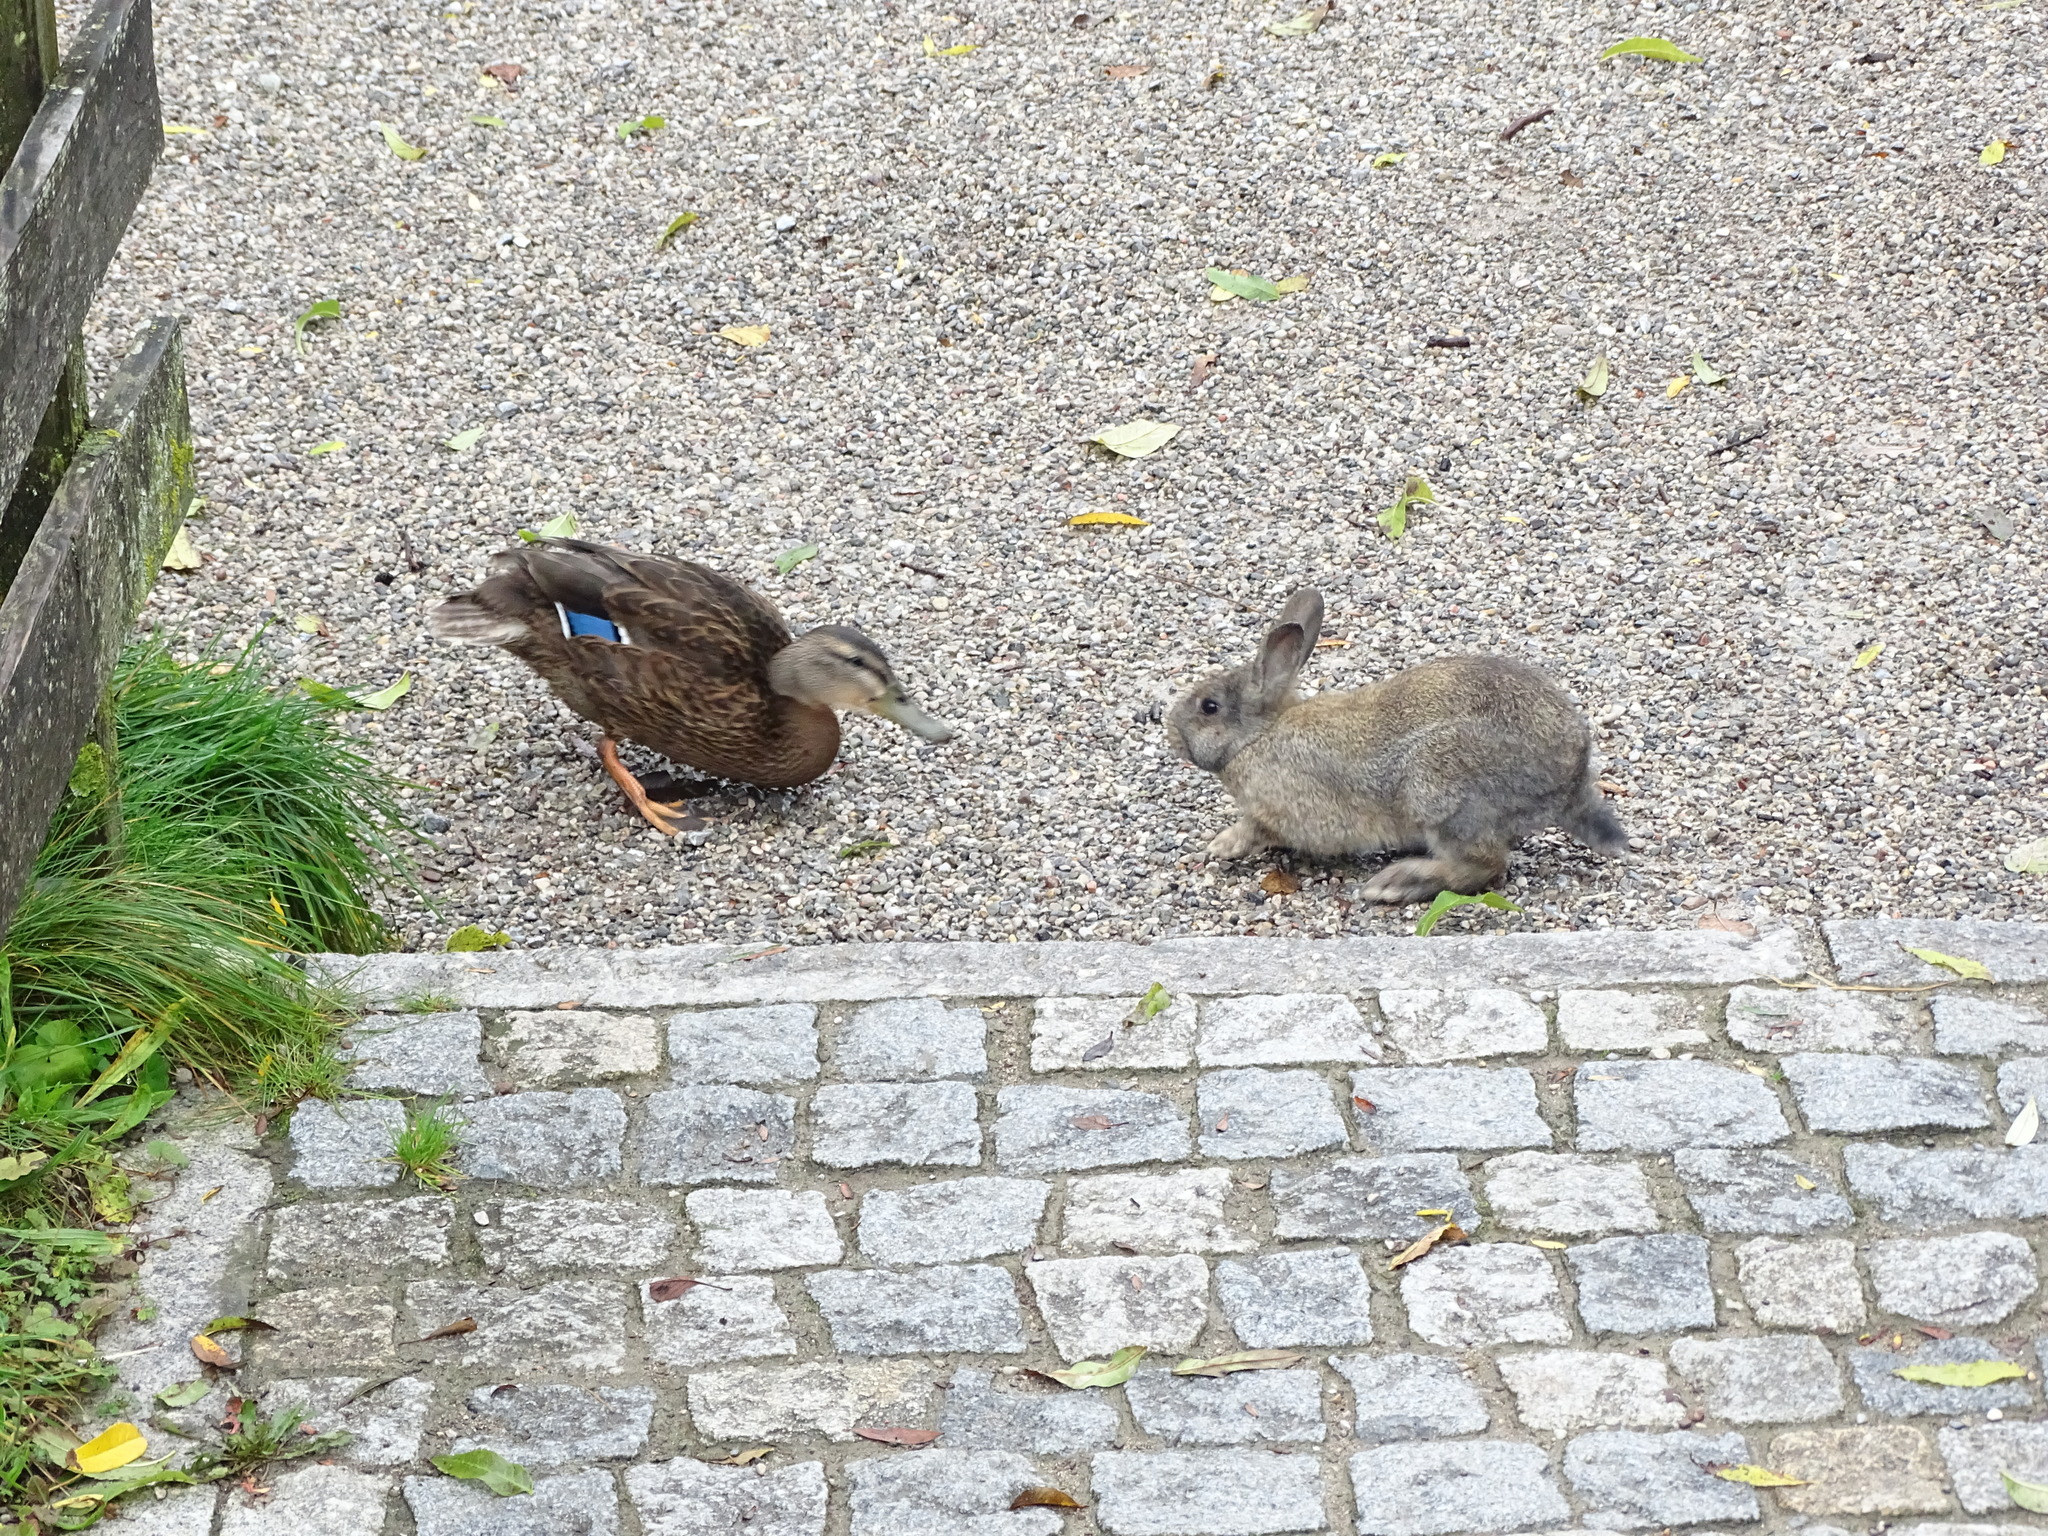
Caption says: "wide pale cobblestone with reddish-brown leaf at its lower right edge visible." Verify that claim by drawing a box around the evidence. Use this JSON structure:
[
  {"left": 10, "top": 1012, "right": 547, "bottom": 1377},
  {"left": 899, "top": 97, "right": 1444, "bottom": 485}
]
[{"left": 690, "top": 1360, "right": 937, "bottom": 1448}]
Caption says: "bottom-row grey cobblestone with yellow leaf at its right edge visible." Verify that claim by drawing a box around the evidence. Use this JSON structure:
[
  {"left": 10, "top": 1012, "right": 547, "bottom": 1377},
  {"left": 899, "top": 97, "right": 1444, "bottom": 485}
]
[{"left": 1565, "top": 1430, "right": 1757, "bottom": 1530}]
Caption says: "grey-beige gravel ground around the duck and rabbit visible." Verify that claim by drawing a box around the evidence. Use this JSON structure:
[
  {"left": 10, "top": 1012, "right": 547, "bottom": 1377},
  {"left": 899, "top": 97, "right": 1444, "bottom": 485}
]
[{"left": 75, "top": 0, "right": 2048, "bottom": 944}]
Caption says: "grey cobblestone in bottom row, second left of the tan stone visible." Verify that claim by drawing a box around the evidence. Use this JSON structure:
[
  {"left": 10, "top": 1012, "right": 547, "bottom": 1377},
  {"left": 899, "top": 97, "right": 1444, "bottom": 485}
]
[{"left": 1359, "top": 1440, "right": 1571, "bottom": 1536}]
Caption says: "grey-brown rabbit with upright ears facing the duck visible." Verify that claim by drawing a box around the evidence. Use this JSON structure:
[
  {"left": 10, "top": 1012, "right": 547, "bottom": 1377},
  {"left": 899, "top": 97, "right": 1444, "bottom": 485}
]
[{"left": 1165, "top": 586, "right": 1628, "bottom": 901}]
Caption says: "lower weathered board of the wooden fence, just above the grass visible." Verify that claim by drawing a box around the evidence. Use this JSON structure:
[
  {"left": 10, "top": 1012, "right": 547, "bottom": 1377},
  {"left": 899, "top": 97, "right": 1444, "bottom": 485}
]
[{"left": 0, "top": 317, "right": 193, "bottom": 934}]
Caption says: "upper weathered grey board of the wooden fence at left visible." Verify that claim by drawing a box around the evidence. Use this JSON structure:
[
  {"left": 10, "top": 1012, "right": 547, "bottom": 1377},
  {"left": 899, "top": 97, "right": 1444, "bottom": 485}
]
[{"left": 0, "top": 0, "right": 164, "bottom": 514}]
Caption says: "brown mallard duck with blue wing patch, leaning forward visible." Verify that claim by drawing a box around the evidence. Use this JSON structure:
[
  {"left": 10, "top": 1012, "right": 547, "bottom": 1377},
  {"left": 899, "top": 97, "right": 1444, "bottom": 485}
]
[{"left": 428, "top": 539, "right": 952, "bottom": 836}]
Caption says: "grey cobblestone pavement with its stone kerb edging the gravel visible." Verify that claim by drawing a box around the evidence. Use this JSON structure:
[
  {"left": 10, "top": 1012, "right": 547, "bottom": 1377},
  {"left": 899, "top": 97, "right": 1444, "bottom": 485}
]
[{"left": 104, "top": 922, "right": 2048, "bottom": 1536}]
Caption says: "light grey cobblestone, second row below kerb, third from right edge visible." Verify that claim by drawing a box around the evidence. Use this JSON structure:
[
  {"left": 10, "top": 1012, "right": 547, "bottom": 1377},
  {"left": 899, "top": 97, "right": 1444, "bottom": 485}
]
[{"left": 1573, "top": 1061, "right": 1792, "bottom": 1151}]
